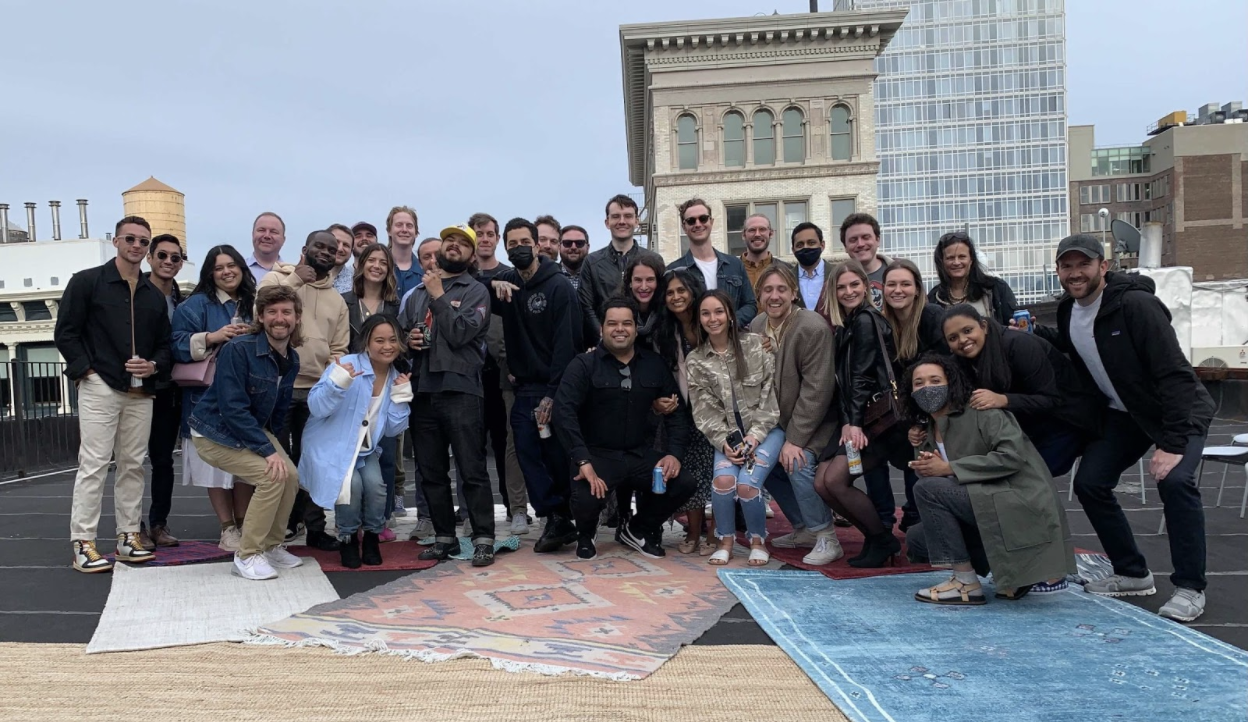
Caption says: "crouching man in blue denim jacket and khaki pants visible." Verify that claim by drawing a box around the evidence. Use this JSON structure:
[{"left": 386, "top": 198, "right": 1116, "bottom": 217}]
[{"left": 188, "top": 286, "right": 307, "bottom": 580}]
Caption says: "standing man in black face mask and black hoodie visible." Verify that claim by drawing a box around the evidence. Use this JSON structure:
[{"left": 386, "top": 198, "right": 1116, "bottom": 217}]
[{"left": 492, "top": 218, "right": 585, "bottom": 552}]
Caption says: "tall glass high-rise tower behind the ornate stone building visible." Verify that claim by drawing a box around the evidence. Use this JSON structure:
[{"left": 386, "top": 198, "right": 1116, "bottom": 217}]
[{"left": 836, "top": 0, "right": 1070, "bottom": 302}]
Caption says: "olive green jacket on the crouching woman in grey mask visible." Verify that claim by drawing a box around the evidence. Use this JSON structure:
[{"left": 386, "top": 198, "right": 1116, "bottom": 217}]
[{"left": 922, "top": 408, "right": 1077, "bottom": 589}]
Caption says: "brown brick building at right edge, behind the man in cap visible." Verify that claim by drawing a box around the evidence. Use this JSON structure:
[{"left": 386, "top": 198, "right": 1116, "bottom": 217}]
[{"left": 1067, "top": 103, "right": 1248, "bottom": 281}]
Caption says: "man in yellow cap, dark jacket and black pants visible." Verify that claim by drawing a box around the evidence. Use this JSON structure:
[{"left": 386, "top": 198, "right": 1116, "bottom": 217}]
[{"left": 399, "top": 226, "right": 494, "bottom": 566}]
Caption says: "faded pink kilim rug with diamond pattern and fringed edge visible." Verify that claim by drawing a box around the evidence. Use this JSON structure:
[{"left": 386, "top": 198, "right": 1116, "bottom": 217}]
[{"left": 251, "top": 540, "right": 736, "bottom": 680}]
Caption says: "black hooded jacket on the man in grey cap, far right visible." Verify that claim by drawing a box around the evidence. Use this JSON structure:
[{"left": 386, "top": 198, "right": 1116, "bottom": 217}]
[{"left": 1055, "top": 273, "right": 1214, "bottom": 454}]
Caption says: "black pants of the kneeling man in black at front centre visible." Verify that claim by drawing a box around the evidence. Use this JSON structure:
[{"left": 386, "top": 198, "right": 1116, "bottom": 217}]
[{"left": 572, "top": 448, "right": 698, "bottom": 539}]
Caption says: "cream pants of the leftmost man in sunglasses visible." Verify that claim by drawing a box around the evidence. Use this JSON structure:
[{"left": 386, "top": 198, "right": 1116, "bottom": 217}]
[{"left": 70, "top": 374, "right": 152, "bottom": 541}]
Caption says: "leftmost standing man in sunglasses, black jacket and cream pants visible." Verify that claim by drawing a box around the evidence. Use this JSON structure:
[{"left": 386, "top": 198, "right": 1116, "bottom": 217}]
[{"left": 54, "top": 216, "right": 171, "bottom": 572}]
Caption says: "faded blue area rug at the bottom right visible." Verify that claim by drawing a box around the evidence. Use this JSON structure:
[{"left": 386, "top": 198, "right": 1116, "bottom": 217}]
[{"left": 719, "top": 570, "right": 1248, "bottom": 722}]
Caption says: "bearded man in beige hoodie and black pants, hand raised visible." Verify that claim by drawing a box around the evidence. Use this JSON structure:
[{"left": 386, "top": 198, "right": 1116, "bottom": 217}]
[{"left": 260, "top": 231, "right": 351, "bottom": 551}]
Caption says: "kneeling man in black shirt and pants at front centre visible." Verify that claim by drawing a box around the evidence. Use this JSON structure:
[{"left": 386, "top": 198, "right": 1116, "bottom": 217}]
[{"left": 554, "top": 298, "right": 696, "bottom": 560}]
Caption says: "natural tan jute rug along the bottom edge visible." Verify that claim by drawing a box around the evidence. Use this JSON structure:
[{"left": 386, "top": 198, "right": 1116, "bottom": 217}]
[{"left": 0, "top": 643, "right": 845, "bottom": 722}]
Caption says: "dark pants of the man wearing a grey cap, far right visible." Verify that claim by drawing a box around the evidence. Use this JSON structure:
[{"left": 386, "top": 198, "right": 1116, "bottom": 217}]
[{"left": 1075, "top": 409, "right": 1206, "bottom": 591}]
